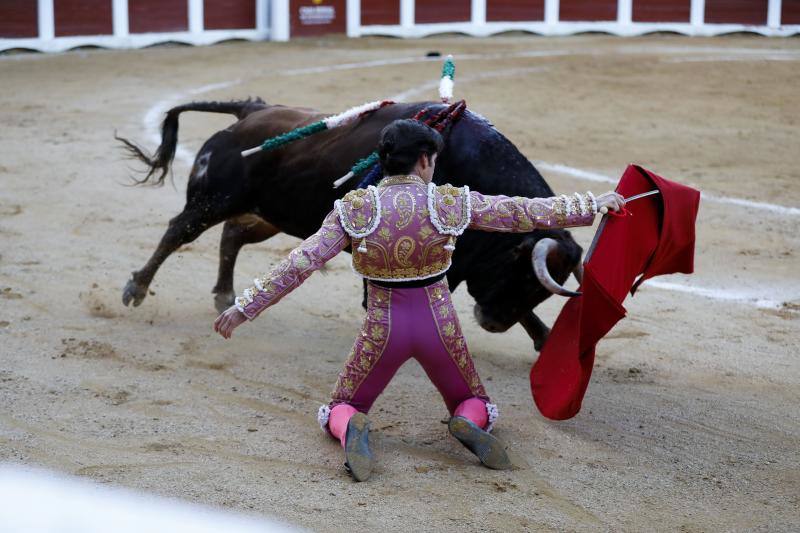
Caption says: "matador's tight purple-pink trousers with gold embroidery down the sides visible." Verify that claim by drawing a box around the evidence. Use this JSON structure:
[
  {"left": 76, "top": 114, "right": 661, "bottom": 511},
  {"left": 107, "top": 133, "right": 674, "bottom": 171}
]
[{"left": 328, "top": 279, "right": 488, "bottom": 445}]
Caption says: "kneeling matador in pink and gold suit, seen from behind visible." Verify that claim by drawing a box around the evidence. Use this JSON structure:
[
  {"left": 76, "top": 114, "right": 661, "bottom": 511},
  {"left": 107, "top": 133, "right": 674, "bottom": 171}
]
[{"left": 214, "top": 120, "right": 624, "bottom": 481}]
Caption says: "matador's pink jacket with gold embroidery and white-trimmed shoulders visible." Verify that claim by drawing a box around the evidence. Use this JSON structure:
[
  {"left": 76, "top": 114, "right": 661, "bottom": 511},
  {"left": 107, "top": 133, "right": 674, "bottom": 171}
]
[{"left": 236, "top": 176, "right": 597, "bottom": 320}]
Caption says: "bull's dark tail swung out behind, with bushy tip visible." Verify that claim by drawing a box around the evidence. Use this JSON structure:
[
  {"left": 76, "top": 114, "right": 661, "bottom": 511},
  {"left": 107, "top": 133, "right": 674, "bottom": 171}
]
[{"left": 114, "top": 98, "right": 267, "bottom": 186}]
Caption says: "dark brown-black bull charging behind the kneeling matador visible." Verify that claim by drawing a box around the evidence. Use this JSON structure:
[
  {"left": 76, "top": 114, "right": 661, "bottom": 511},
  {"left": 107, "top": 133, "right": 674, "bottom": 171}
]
[{"left": 118, "top": 99, "right": 582, "bottom": 349}]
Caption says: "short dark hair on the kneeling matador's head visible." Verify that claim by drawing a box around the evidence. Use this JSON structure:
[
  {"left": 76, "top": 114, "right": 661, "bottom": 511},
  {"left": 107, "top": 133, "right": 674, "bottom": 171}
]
[{"left": 378, "top": 118, "right": 444, "bottom": 176}]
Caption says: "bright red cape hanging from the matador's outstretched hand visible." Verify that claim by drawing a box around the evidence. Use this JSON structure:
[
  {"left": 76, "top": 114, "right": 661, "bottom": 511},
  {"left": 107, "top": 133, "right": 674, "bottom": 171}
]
[{"left": 530, "top": 165, "right": 700, "bottom": 420}]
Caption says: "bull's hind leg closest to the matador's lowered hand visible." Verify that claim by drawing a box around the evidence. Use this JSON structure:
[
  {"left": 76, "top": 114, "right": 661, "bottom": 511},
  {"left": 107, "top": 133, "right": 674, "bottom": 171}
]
[{"left": 211, "top": 214, "right": 281, "bottom": 313}]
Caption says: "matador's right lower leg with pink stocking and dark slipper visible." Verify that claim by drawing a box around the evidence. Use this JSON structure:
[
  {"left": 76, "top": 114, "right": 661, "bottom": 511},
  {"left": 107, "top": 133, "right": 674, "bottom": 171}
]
[{"left": 447, "top": 398, "right": 513, "bottom": 470}]
